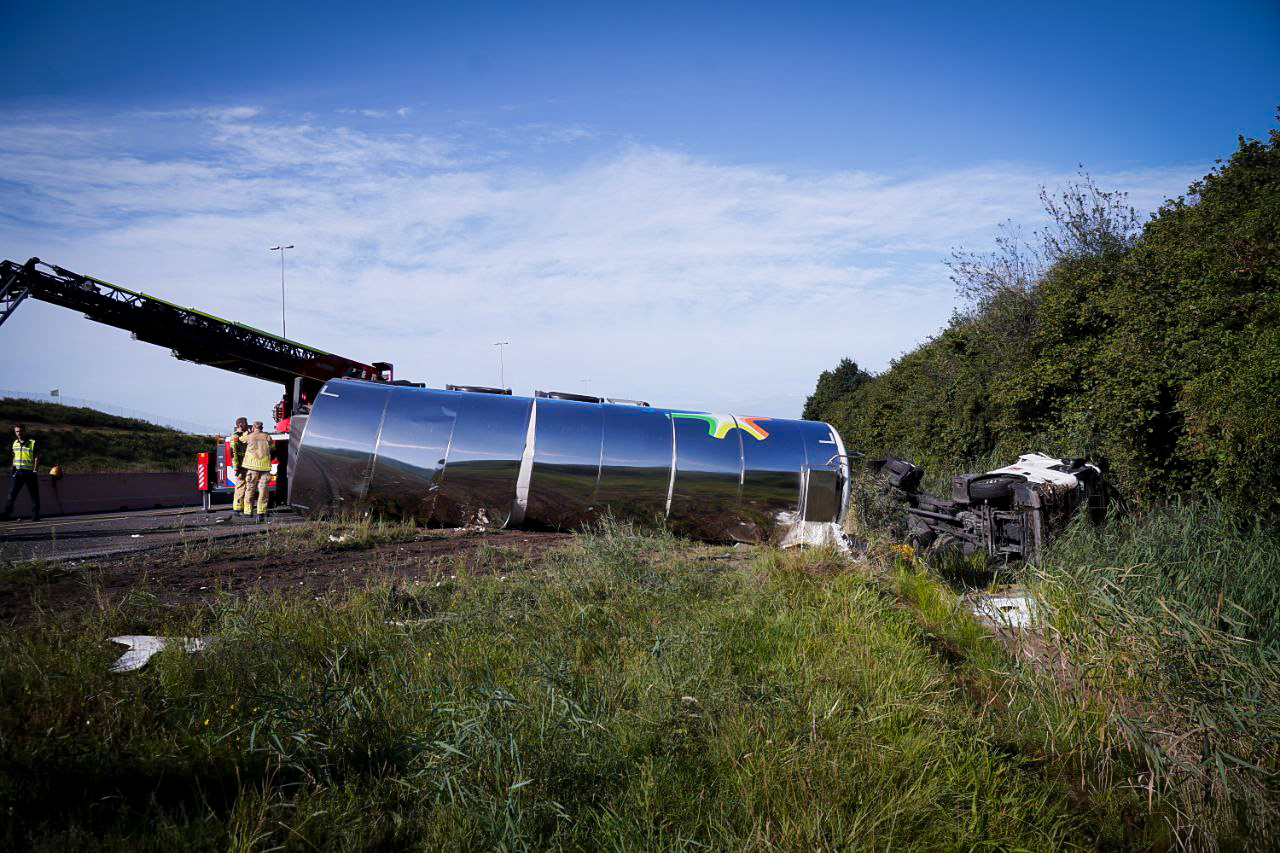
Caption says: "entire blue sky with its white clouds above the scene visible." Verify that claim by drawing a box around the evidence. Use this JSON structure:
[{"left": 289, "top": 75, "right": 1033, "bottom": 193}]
[{"left": 0, "top": 3, "right": 1280, "bottom": 425}]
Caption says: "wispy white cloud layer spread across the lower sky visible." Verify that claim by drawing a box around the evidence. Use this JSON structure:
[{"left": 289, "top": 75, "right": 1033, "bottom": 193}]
[{"left": 0, "top": 106, "right": 1196, "bottom": 432}]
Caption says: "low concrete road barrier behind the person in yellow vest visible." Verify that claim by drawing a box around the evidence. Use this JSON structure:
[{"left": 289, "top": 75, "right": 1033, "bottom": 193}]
[{"left": 0, "top": 473, "right": 201, "bottom": 516}]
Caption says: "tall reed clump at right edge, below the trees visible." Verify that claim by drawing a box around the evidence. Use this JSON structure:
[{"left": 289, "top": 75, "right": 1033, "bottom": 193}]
[{"left": 1030, "top": 502, "right": 1280, "bottom": 849}]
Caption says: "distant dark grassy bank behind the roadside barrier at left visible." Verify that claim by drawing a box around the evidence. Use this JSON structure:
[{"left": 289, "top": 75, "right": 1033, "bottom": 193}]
[{"left": 0, "top": 397, "right": 214, "bottom": 474}]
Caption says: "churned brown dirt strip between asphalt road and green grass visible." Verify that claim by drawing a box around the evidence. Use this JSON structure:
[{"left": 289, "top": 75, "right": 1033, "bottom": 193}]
[{"left": 0, "top": 526, "right": 572, "bottom": 624}]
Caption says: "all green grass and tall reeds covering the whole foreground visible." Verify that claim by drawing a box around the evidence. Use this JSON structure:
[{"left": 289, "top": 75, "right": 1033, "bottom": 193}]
[{"left": 0, "top": 507, "right": 1280, "bottom": 849}]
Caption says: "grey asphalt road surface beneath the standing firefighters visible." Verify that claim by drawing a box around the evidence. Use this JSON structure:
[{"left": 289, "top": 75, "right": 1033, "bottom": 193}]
[{"left": 0, "top": 507, "right": 302, "bottom": 561}]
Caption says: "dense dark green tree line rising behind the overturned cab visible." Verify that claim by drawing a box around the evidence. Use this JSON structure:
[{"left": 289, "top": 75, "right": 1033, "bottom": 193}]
[{"left": 805, "top": 125, "right": 1280, "bottom": 514}]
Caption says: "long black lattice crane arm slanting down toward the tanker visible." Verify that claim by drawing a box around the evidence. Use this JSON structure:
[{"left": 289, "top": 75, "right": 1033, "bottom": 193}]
[{"left": 0, "top": 257, "right": 392, "bottom": 387}]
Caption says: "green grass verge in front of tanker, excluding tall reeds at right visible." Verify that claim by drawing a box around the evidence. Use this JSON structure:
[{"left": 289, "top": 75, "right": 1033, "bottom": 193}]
[{"left": 0, "top": 517, "right": 1165, "bottom": 849}]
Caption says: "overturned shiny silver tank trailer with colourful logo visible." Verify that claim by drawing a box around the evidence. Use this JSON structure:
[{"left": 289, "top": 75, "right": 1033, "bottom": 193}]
[{"left": 289, "top": 379, "right": 850, "bottom": 544}]
